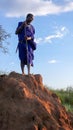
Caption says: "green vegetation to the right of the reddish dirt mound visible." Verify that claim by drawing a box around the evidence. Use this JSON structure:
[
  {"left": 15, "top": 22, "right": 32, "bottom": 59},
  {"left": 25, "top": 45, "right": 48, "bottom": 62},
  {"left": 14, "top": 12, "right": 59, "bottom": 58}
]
[{"left": 53, "top": 87, "right": 73, "bottom": 113}]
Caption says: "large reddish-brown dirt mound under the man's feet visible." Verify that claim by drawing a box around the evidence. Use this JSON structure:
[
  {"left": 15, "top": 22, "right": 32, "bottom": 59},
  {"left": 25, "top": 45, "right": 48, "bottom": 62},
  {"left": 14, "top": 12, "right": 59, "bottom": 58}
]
[{"left": 0, "top": 72, "right": 73, "bottom": 130}]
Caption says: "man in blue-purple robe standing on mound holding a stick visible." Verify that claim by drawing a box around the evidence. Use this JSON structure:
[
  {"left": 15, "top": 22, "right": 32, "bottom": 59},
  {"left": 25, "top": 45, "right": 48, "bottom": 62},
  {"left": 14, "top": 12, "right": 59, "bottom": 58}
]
[{"left": 15, "top": 13, "right": 36, "bottom": 75}]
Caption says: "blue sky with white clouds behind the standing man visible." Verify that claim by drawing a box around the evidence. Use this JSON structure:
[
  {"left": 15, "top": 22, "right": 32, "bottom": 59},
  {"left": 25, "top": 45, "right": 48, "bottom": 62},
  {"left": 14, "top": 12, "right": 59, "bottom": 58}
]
[{"left": 0, "top": 0, "right": 73, "bottom": 89}]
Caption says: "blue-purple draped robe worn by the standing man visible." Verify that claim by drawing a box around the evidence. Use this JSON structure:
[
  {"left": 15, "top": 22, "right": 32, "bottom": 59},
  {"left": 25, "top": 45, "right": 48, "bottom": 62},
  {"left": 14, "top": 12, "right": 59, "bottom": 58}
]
[{"left": 18, "top": 22, "right": 36, "bottom": 66}]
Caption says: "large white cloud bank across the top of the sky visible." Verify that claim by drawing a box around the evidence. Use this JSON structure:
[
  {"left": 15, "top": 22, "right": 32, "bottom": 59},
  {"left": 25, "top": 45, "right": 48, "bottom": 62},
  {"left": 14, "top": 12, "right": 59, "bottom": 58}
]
[{"left": 0, "top": 0, "right": 73, "bottom": 17}]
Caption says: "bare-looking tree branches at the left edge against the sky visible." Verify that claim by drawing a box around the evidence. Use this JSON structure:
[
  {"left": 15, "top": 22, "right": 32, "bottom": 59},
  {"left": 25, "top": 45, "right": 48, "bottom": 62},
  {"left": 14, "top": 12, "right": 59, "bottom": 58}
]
[{"left": 0, "top": 25, "right": 10, "bottom": 53}]
